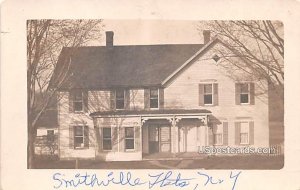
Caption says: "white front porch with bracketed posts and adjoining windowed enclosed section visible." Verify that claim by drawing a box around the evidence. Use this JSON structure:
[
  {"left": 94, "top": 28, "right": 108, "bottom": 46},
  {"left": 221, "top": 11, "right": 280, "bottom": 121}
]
[{"left": 91, "top": 109, "right": 211, "bottom": 161}]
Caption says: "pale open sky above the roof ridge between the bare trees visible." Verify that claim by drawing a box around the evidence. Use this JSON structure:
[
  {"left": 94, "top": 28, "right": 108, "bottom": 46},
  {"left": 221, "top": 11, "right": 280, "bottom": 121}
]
[{"left": 95, "top": 20, "right": 207, "bottom": 45}]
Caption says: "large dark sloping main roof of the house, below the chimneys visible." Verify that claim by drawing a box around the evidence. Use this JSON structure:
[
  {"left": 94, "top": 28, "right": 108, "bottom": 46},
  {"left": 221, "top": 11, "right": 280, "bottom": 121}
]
[{"left": 49, "top": 44, "right": 204, "bottom": 89}]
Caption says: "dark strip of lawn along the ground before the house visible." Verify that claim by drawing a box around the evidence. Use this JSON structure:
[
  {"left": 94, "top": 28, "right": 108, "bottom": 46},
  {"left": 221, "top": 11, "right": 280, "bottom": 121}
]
[{"left": 35, "top": 155, "right": 284, "bottom": 170}]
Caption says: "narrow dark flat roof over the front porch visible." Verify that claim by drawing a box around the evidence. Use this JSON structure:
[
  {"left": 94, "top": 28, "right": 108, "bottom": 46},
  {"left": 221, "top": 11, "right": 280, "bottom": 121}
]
[{"left": 90, "top": 109, "right": 211, "bottom": 117}]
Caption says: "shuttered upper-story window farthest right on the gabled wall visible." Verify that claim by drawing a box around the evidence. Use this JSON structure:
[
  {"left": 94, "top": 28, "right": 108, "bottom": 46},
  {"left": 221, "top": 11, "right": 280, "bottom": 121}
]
[{"left": 235, "top": 83, "right": 254, "bottom": 104}]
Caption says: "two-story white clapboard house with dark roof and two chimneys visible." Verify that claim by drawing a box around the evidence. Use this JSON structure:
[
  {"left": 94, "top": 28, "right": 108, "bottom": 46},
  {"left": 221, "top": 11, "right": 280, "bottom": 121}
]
[{"left": 50, "top": 31, "right": 269, "bottom": 161}]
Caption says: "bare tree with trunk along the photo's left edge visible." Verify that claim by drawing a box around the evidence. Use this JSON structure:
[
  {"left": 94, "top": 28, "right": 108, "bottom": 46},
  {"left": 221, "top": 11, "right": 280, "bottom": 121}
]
[{"left": 27, "top": 20, "right": 103, "bottom": 168}]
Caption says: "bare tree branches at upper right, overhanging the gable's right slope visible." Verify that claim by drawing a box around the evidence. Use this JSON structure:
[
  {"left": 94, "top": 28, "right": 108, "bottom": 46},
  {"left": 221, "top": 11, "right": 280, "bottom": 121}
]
[{"left": 199, "top": 20, "right": 284, "bottom": 95}]
